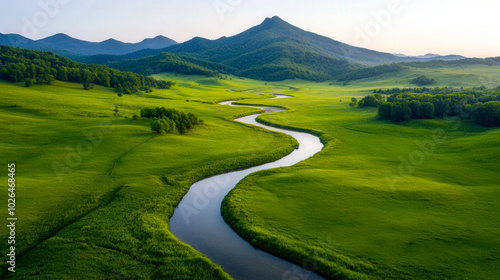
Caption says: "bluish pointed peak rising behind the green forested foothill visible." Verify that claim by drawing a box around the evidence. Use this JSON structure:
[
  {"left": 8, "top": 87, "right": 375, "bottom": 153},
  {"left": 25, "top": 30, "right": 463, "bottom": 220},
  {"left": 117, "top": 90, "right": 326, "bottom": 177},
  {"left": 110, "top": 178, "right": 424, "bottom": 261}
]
[{"left": 163, "top": 16, "right": 463, "bottom": 66}]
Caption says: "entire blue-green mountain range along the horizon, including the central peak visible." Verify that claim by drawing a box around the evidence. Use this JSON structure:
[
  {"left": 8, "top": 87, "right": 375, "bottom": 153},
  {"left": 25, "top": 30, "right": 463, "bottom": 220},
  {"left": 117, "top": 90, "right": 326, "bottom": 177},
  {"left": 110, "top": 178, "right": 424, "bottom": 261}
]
[{"left": 0, "top": 16, "right": 465, "bottom": 81}]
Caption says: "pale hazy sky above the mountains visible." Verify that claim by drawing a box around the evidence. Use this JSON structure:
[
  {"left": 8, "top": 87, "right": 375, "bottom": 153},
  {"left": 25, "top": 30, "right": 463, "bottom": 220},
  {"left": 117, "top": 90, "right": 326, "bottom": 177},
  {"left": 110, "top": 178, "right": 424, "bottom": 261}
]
[{"left": 0, "top": 0, "right": 500, "bottom": 57}]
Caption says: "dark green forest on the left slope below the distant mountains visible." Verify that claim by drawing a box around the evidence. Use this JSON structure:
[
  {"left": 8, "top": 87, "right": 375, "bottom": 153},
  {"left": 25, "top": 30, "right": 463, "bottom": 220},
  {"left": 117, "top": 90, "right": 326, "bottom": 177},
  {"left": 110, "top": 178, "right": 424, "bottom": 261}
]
[{"left": 0, "top": 46, "right": 175, "bottom": 94}]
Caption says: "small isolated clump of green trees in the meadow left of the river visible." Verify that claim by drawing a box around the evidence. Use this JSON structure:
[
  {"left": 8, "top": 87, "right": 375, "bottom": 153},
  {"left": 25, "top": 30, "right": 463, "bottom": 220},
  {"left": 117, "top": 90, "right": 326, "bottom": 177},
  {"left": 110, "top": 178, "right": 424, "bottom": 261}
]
[{"left": 141, "top": 107, "right": 203, "bottom": 134}]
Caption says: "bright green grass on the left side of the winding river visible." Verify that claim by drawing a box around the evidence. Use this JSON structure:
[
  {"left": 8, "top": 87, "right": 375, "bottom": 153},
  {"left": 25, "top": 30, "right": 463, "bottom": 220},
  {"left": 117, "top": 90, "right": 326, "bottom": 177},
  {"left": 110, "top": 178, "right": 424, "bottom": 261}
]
[{"left": 0, "top": 77, "right": 295, "bottom": 279}]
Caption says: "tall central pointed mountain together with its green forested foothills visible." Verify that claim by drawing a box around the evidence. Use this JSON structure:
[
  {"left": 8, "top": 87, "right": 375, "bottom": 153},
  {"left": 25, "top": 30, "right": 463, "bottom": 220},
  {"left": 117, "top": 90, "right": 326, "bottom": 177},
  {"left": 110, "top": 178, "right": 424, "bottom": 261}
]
[{"left": 82, "top": 16, "right": 463, "bottom": 81}]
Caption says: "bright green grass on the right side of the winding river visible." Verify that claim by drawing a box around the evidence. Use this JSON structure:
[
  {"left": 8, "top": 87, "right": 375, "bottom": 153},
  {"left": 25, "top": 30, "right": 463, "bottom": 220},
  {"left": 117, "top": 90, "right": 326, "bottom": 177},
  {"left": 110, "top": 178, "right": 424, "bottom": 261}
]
[{"left": 223, "top": 71, "right": 500, "bottom": 279}]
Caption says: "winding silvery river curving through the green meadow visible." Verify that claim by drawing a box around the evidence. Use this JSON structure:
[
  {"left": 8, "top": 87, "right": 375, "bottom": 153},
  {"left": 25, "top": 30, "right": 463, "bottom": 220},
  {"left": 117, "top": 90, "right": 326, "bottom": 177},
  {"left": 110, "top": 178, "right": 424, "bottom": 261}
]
[{"left": 170, "top": 95, "right": 323, "bottom": 280}]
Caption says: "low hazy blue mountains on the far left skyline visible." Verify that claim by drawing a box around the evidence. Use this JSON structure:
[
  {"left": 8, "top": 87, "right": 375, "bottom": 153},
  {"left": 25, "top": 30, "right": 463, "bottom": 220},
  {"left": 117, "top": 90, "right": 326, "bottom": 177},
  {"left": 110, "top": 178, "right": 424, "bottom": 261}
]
[{"left": 0, "top": 33, "right": 177, "bottom": 57}]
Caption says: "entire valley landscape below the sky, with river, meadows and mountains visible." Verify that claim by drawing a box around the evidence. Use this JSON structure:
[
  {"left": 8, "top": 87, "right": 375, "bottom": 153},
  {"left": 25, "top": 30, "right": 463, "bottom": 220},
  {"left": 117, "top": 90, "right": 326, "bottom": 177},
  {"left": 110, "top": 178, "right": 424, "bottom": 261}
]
[{"left": 0, "top": 13, "right": 500, "bottom": 280}]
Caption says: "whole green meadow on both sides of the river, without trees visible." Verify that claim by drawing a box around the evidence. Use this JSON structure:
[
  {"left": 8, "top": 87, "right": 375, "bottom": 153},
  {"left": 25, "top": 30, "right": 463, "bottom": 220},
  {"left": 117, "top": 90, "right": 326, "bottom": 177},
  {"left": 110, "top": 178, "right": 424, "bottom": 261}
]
[{"left": 0, "top": 66, "right": 500, "bottom": 280}]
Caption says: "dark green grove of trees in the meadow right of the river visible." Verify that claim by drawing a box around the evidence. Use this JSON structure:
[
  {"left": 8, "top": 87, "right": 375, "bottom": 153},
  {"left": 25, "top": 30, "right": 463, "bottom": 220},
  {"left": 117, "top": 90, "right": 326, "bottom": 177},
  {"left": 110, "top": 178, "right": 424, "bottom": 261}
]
[{"left": 368, "top": 88, "right": 500, "bottom": 126}]
